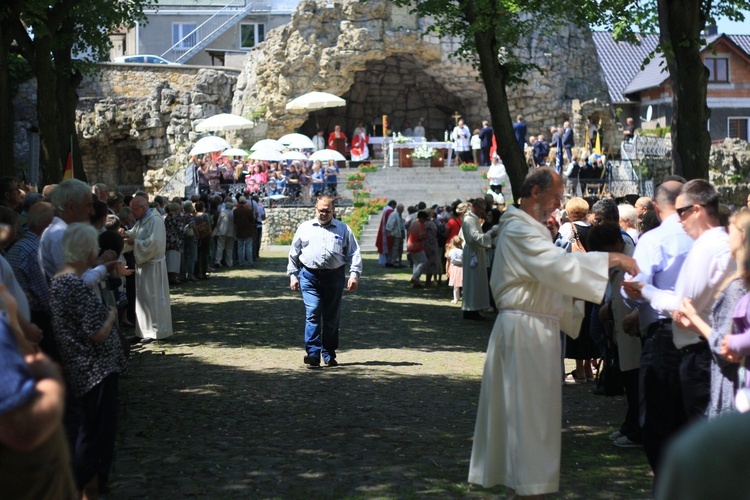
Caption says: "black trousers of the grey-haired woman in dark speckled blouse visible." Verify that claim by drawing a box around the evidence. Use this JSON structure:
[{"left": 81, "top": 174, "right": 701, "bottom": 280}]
[{"left": 73, "top": 373, "right": 120, "bottom": 490}]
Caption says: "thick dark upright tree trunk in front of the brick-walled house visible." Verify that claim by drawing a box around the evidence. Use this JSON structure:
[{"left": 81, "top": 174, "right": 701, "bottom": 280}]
[{"left": 658, "top": 0, "right": 711, "bottom": 180}]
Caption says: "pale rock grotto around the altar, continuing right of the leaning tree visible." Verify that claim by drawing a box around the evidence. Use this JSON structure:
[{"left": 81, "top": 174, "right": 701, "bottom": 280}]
[{"left": 233, "top": 0, "right": 607, "bottom": 143}]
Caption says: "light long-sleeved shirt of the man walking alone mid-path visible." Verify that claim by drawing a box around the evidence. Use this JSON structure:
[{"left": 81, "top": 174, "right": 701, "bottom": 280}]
[{"left": 286, "top": 219, "right": 362, "bottom": 278}]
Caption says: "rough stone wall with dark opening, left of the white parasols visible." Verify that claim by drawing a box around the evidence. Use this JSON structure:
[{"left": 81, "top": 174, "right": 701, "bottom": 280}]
[{"left": 76, "top": 68, "right": 237, "bottom": 192}]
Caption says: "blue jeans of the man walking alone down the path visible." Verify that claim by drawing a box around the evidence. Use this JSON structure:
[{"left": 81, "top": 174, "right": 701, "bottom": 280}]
[{"left": 299, "top": 266, "right": 346, "bottom": 362}]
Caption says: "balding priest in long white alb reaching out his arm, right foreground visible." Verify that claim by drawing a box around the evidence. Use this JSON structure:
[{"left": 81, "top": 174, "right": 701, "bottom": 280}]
[{"left": 469, "top": 167, "right": 637, "bottom": 497}]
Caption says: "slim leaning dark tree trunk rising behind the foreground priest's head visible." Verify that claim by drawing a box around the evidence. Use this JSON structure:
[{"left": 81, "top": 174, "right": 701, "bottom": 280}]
[{"left": 474, "top": 31, "right": 528, "bottom": 200}]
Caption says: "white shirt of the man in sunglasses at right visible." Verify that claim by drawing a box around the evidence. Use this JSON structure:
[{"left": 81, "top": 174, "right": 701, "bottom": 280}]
[{"left": 636, "top": 227, "right": 736, "bottom": 349}]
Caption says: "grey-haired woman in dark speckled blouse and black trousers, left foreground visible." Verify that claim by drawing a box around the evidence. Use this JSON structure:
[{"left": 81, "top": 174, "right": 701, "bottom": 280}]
[{"left": 50, "top": 223, "right": 126, "bottom": 498}]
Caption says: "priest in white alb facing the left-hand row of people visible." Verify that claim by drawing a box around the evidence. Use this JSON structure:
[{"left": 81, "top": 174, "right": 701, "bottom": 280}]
[{"left": 124, "top": 196, "right": 172, "bottom": 340}]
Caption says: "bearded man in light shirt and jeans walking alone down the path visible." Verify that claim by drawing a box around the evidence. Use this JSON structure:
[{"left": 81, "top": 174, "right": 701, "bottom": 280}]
[{"left": 286, "top": 196, "right": 362, "bottom": 368}]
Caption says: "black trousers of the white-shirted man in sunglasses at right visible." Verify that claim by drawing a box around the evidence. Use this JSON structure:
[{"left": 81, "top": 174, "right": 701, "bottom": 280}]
[{"left": 680, "top": 341, "right": 711, "bottom": 420}]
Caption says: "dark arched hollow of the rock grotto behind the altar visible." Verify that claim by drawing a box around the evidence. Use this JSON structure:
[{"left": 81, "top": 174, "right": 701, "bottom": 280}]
[{"left": 299, "top": 54, "right": 463, "bottom": 139}]
